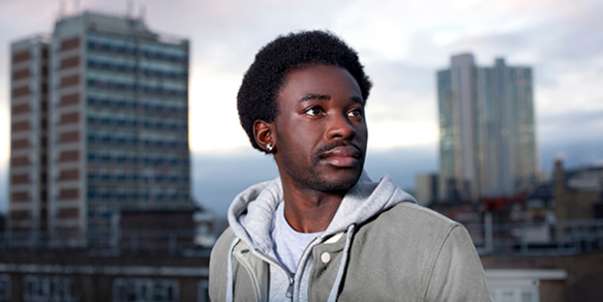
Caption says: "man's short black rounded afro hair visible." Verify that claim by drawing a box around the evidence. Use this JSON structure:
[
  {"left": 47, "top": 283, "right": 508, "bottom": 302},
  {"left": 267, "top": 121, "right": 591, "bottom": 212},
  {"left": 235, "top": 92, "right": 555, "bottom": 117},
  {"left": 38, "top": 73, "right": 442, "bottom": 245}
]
[{"left": 237, "top": 30, "right": 372, "bottom": 152}]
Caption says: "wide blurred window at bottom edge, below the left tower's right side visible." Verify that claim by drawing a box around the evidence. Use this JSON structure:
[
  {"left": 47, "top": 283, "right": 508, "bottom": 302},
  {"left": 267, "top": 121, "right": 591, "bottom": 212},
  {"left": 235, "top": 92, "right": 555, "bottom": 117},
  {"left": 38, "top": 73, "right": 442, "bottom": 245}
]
[{"left": 113, "top": 278, "right": 180, "bottom": 302}]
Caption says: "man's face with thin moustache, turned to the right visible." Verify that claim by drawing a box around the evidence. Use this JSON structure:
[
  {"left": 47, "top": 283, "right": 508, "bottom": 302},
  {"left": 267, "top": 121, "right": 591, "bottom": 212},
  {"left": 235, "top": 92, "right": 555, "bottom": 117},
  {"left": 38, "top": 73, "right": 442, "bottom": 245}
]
[{"left": 274, "top": 65, "right": 368, "bottom": 192}]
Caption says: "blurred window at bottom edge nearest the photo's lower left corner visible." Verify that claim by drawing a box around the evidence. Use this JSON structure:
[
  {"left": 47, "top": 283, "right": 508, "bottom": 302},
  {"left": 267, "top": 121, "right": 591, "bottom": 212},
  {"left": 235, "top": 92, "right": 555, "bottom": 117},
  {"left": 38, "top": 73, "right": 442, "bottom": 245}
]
[{"left": 23, "top": 275, "right": 78, "bottom": 302}]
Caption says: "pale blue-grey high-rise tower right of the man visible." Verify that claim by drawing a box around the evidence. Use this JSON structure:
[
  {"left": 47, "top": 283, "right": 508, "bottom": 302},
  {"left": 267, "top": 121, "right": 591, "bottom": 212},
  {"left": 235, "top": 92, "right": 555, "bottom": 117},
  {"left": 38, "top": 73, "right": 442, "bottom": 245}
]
[{"left": 437, "top": 54, "right": 537, "bottom": 200}]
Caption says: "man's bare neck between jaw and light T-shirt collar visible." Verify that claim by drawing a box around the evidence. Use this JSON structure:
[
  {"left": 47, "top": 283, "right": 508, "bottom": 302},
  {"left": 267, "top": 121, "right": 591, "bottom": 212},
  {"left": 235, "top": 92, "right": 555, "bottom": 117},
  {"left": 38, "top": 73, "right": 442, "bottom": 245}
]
[{"left": 281, "top": 178, "right": 344, "bottom": 233}]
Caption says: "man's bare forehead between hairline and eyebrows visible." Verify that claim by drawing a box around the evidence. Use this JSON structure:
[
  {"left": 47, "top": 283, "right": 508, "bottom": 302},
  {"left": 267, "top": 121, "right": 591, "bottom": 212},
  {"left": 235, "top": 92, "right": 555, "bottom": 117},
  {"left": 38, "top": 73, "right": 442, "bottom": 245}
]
[{"left": 277, "top": 65, "right": 361, "bottom": 102}]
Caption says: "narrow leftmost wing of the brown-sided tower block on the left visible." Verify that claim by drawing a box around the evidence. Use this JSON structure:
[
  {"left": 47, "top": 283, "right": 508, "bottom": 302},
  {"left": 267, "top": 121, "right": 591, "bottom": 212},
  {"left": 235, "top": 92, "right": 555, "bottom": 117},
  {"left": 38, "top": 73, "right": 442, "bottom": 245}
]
[{"left": 7, "top": 35, "right": 49, "bottom": 239}]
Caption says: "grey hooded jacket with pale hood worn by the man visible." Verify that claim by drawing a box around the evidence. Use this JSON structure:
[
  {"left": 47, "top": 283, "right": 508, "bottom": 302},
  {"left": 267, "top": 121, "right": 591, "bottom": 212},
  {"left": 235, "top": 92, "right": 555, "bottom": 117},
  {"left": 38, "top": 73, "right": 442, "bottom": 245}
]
[{"left": 209, "top": 174, "right": 490, "bottom": 302}]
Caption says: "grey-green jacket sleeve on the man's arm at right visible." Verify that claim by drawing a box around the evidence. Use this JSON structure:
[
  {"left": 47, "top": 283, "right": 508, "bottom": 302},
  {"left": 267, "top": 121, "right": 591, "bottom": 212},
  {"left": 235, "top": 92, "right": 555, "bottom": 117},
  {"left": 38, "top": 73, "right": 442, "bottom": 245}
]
[{"left": 425, "top": 224, "right": 491, "bottom": 302}]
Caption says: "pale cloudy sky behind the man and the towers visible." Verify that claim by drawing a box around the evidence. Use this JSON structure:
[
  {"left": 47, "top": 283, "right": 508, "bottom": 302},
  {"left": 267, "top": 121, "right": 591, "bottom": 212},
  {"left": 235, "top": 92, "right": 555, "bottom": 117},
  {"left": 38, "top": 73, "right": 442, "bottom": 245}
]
[{"left": 0, "top": 0, "right": 603, "bottom": 213}]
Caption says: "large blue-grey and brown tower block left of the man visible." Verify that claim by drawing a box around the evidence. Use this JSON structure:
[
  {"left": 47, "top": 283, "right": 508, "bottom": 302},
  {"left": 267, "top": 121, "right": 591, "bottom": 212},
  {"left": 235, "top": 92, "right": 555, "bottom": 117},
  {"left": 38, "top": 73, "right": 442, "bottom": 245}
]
[{"left": 9, "top": 12, "right": 193, "bottom": 245}]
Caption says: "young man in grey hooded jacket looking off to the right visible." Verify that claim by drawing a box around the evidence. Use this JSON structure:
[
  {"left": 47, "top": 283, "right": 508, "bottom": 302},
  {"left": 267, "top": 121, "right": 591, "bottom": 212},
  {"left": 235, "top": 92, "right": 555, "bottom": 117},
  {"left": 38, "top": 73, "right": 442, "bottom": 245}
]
[{"left": 209, "top": 31, "right": 489, "bottom": 302}]
